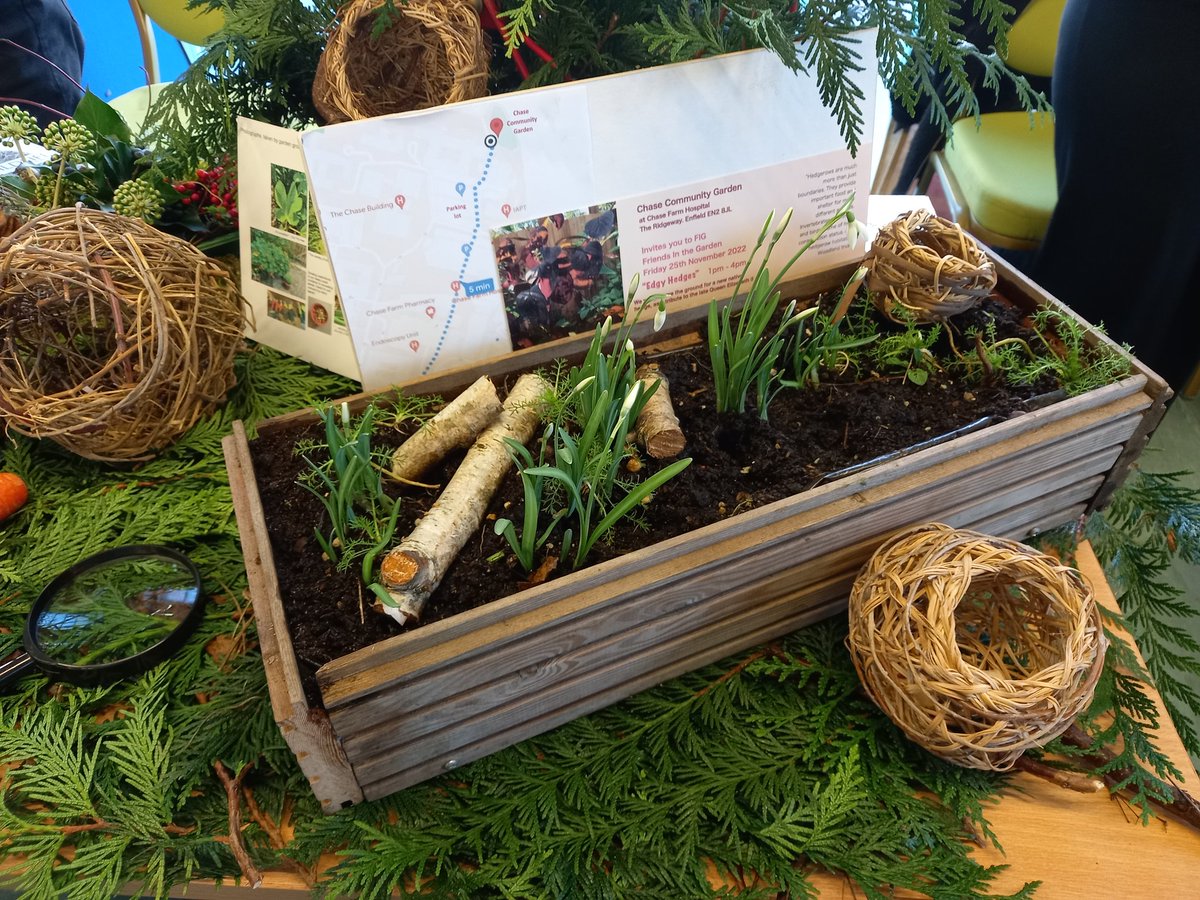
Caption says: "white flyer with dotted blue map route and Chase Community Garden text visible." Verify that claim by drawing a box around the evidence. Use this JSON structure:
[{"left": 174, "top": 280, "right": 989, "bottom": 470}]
[{"left": 302, "top": 39, "right": 875, "bottom": 390}]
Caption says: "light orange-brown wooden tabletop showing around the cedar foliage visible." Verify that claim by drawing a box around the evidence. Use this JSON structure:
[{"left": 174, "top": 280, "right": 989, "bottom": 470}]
[{"left": 172, "top": 545, "right": 1200, "bottom": 900}]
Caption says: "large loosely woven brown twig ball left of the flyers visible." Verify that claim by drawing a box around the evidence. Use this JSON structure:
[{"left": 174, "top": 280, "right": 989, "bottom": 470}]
[{"left": 0, "top": 208, "right": 245, "bottom": 461}]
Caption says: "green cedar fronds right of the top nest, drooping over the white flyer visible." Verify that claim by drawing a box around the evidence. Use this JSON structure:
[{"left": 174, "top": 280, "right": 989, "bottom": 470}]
[{"left": 503, "top": 0, "right": 1049, "bottom": 152}]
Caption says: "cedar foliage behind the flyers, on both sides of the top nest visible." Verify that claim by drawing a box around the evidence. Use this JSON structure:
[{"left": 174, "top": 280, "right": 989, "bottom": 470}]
[{"left": 148, "top": 0, "right": 1048, "bottom": 166}]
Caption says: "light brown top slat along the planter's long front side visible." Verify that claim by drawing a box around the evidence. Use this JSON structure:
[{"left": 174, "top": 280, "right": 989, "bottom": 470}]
[{"left": 319, "top": 396, "right": 1142, "bottom": 716}]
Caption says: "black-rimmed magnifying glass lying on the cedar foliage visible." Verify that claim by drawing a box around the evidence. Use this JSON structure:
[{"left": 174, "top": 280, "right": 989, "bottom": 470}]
[{"left": 0, "top": 545, "right": 204, "bottom": 688}]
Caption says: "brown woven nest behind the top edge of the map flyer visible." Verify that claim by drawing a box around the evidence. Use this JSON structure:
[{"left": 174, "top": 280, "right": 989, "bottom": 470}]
[{"left": 312, "top": 0, "right": 488, "bottom": 124}]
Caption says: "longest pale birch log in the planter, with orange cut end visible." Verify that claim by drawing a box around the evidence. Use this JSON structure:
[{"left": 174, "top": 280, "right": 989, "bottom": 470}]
[{"left": 379, "top": 374, "right": 551, "bottom": 625}]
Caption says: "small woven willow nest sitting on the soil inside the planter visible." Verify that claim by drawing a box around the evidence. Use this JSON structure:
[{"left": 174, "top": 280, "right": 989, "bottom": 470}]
[{"left": 866, "top": 210, "right": 996, "bottom": 323}]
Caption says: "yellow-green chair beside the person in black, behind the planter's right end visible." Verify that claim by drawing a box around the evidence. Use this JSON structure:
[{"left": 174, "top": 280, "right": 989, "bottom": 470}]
[{"left": 932, "top": 0, "right": 1066, "bottom": 250}]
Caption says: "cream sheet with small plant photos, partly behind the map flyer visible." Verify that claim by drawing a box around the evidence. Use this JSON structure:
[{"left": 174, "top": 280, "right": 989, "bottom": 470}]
[{"left": 238, "top": 119, "right": 360, "bottom": 378}]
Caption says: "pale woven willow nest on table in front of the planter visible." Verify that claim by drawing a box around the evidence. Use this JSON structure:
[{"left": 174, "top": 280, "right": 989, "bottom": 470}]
[{"left": 850, "top": 523, "right": 1105, "bottom": 772}]
